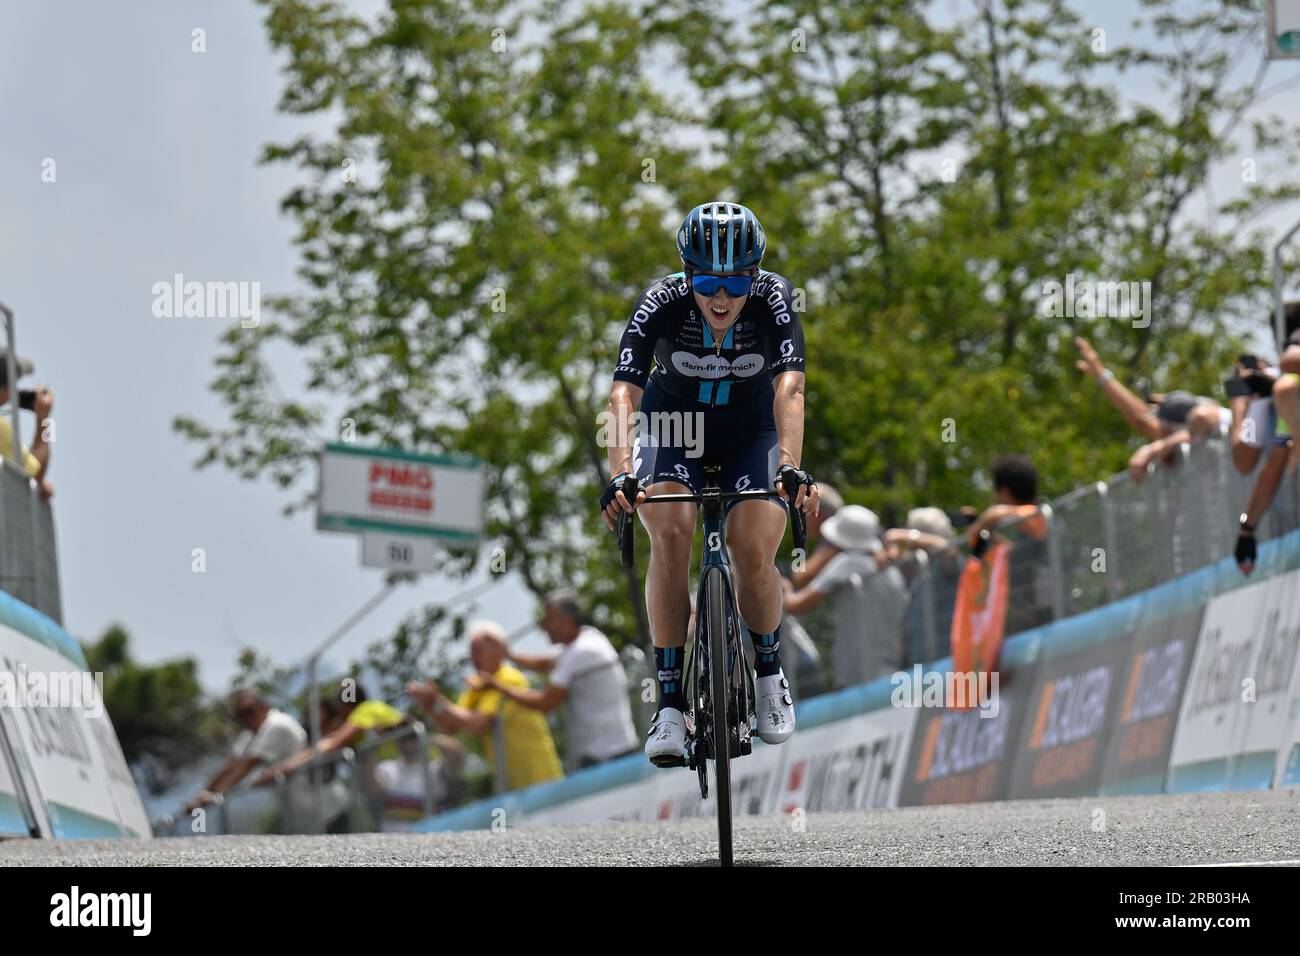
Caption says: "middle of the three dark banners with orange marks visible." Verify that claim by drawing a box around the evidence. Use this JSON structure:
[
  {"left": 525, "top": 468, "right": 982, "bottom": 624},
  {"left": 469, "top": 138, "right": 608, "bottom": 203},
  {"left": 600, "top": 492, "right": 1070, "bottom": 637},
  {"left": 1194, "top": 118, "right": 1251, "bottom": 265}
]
[{"left": 1008, "top": 640, "right": 1128, "bottom": 800}]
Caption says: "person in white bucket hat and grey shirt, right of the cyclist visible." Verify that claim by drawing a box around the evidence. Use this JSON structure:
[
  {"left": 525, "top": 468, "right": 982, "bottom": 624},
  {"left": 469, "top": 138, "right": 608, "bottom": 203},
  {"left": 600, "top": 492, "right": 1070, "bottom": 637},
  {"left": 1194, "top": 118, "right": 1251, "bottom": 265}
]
[{"left": 785, "top": 505, "right": 907, "bottom": 687}]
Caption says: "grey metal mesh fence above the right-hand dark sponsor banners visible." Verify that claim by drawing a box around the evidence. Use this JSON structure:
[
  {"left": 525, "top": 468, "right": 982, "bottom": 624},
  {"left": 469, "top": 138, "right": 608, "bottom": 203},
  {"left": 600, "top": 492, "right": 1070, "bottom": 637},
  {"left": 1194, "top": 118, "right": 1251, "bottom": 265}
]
[{"left": 905, "top": 436, "right": 1300, "bottom": 663}]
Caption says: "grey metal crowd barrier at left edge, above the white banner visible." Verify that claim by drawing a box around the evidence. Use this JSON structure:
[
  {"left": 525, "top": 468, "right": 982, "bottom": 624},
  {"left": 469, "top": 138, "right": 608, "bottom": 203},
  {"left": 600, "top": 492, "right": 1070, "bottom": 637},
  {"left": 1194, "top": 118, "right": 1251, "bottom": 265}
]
[{"left": 0, "top": 459, "right": 64, "bottom": 624}]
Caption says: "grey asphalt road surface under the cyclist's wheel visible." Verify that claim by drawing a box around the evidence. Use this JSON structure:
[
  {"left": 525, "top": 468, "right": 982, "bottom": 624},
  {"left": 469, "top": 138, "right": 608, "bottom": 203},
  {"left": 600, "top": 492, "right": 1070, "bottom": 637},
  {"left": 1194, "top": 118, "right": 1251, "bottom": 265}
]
[{"left": 0, "top": 790, "right": 1300, "bottom": 866}]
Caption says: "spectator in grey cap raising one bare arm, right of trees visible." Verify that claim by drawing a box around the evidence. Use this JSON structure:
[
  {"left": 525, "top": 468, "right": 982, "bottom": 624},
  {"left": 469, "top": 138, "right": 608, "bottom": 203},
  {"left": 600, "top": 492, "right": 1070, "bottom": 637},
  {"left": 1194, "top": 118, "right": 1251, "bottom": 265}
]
[{"left": 1074, "top": 338, "right": 1231, "bottom": 483}]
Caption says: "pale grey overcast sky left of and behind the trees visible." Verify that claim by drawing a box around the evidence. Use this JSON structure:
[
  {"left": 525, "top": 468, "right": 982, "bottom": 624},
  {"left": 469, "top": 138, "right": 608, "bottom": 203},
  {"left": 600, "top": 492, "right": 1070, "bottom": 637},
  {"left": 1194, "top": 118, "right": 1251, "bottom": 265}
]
[{"left": 0, "top": 0, "right": 1300, "bottom": 689}]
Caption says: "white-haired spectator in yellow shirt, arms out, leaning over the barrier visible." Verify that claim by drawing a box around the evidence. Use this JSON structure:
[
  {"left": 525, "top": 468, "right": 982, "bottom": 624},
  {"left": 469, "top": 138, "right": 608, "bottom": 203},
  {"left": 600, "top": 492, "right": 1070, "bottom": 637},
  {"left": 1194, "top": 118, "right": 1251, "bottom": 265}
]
[{"left": 407, "top": 620, "right": 564, "bottom": 790}]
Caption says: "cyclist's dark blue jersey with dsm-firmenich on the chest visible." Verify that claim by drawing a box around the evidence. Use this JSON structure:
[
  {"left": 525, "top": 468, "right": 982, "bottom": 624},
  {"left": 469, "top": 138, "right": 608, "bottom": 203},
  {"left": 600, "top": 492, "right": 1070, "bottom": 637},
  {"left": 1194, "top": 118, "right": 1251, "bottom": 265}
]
[{"left": 614, "top": 271, "right": 803, "bottom": 406}]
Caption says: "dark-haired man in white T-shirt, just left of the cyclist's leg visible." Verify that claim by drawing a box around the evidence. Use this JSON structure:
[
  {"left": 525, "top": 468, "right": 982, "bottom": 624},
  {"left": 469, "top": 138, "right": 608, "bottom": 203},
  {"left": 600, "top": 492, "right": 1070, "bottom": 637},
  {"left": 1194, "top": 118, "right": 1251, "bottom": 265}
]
[{"left": 482, "top": 591, "right": 641, "bottom": 770}]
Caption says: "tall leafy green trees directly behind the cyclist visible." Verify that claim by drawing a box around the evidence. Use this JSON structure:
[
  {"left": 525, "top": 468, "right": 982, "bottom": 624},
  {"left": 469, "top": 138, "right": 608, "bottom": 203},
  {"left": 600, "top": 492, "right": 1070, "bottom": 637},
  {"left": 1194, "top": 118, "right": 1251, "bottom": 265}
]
[{"left": 177, "top": 0, "right": 1297, "bottom": 655}]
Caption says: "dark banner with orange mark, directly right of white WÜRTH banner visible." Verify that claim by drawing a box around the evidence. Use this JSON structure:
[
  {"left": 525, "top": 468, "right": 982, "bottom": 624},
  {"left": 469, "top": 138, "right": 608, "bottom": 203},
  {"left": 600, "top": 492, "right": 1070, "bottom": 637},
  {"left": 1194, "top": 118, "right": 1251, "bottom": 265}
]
[{"left": 898, "top": 666, "right": 1036, "bottom": 806}]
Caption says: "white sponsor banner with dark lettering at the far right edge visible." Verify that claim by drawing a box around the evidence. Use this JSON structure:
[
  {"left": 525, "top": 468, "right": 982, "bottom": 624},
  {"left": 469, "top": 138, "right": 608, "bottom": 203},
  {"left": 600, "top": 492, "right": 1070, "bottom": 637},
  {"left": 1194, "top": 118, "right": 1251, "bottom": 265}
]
[{"left": 1167, "top": 572, "right": 1300, "bottom": 792}]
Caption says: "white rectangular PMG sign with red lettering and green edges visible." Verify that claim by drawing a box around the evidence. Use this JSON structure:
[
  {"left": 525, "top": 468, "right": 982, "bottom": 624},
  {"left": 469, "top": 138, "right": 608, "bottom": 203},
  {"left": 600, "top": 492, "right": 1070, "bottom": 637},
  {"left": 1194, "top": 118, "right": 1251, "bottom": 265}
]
[{"left": 316, "top": 444, "right": 482, "bottom": 541}]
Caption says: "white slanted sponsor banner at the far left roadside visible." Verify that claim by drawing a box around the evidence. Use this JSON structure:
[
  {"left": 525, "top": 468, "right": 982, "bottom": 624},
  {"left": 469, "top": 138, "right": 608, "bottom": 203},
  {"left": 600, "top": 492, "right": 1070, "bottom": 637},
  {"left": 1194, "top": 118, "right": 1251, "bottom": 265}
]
[{"left": 0, "top": 626, "right": 150, "bottom": 838}]
